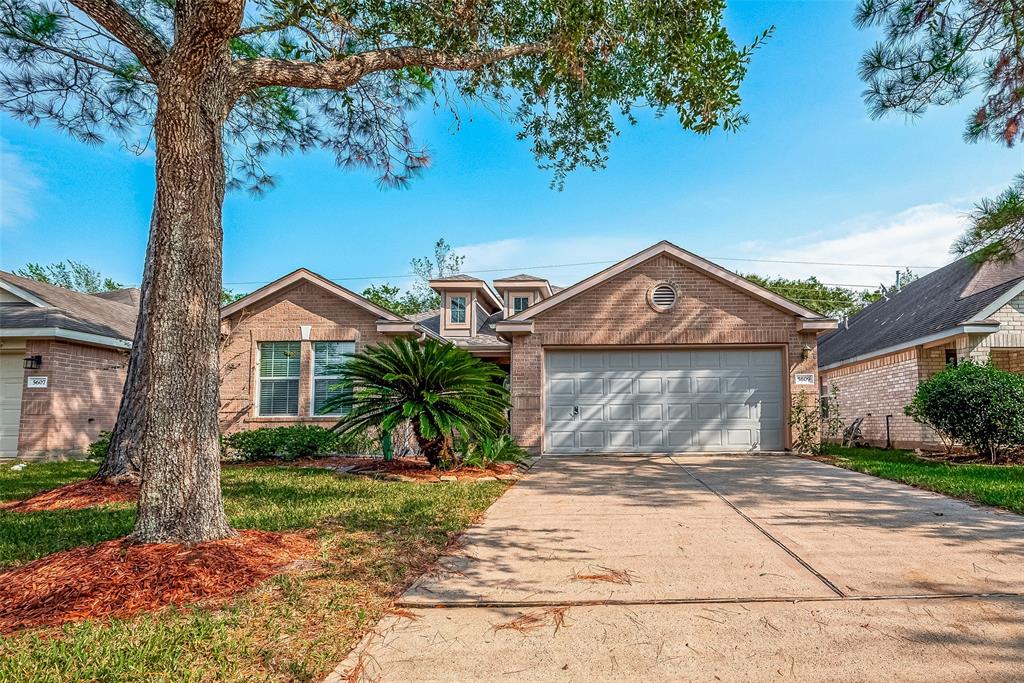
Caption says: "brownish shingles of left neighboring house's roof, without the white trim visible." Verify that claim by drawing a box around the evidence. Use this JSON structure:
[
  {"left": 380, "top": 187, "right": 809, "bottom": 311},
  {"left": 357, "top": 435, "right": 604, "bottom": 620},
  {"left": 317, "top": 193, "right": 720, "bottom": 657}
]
[{"left": 0, "top": 270, "right": 138, "bottom": 341}]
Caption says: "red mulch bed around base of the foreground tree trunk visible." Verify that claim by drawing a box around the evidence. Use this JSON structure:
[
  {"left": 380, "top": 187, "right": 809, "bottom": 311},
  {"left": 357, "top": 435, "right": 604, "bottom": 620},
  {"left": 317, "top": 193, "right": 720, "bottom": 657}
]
[{"left": 0, "top": 530, "right": 315, "bottom": 633}]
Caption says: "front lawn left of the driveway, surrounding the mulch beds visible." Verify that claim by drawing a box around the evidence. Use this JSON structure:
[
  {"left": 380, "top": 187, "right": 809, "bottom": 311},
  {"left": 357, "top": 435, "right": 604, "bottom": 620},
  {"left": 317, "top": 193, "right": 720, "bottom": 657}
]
[{"left": 0, "top": 463, "right": 505, "bottom": 681}]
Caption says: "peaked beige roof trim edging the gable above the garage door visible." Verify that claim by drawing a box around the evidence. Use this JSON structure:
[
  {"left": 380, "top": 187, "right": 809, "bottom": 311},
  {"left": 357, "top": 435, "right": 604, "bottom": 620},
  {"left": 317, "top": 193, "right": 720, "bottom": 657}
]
[{"left": 502, "top": 240, "right": 828, "bottom": 330}]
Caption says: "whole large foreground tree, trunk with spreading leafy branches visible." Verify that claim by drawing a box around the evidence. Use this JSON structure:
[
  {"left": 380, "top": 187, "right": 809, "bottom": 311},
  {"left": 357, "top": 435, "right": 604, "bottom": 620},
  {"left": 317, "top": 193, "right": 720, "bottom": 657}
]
[{"left": 0, "top": 0, "right": 764, "bottom": 542}]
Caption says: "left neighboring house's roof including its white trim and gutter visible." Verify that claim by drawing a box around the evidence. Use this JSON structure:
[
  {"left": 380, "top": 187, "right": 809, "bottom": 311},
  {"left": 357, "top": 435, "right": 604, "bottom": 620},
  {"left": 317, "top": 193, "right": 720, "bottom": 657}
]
[{"left": 0, "top": 270, "right": 138, "bottom": 348}]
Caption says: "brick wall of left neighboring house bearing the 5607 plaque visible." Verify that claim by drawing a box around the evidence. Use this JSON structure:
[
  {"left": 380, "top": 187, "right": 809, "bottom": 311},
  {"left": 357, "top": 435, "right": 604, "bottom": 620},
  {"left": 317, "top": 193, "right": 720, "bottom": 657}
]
[{"left": 17, "top": 339, "right": 128, "bottom": 458}]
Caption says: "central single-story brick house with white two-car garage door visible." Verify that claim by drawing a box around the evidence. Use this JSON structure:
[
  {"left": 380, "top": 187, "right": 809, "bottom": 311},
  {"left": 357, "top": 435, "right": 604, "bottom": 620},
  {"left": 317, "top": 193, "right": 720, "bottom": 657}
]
[{"left": 220, "top": 242, "right": 836, "bottom": 453}]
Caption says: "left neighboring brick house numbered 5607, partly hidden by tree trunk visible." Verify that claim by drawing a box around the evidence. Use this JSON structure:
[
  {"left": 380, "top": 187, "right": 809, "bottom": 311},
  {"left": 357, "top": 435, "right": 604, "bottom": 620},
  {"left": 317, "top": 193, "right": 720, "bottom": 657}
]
[{"left": 0, "top": 271, "right": 138, "bottom": 458}]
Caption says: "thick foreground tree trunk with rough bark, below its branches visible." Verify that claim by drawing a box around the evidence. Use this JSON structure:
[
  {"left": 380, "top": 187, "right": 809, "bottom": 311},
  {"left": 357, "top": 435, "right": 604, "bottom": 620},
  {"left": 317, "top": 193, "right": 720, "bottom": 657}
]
[{"left": 127, "top": 72, "right": 231, "bottom": 543}]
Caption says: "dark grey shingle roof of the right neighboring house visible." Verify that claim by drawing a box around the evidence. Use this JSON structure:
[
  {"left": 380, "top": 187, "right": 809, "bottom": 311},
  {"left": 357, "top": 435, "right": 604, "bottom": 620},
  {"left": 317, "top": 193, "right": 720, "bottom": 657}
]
[{"left": 818, "top": 250, "right": 1024, "bottom": 368}]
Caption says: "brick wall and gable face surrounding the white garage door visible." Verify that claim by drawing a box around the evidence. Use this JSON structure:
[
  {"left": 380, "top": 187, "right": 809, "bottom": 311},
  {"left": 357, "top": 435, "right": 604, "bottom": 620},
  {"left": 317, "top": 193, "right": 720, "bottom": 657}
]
[{"left": 512, "top": 254, "right": 817, "bottom": 451}]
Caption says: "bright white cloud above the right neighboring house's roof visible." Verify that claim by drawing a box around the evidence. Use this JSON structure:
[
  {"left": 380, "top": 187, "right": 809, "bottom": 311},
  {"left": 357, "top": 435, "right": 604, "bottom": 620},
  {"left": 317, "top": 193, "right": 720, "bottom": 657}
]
[{"left": 722, "top": 204, "right": 967, "bottom": 287}]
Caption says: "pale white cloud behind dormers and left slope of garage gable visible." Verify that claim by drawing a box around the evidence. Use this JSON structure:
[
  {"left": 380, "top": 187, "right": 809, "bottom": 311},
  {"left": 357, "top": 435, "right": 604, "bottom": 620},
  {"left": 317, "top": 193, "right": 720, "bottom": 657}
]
[{"left": 455, "top": 236, "right": 657, "bottom": 287}]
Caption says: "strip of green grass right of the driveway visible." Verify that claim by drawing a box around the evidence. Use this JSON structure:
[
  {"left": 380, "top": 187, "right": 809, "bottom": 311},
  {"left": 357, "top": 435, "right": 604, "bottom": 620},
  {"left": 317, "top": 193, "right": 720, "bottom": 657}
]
[{"left": 825, "top": 445, "right": 1024, "bottom": 514}]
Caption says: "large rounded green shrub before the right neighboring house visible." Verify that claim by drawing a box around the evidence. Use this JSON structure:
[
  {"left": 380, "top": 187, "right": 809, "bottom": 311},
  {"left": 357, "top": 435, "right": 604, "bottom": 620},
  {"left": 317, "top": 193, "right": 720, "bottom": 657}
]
[{"left": 903, "top": 360, "right": 1024, "bottom": 463}]
